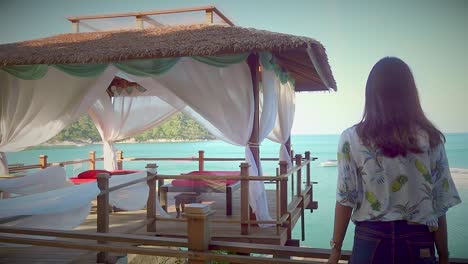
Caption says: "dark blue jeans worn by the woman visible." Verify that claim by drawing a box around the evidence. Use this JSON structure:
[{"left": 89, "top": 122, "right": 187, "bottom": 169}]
[{"left": 349, "top": 221, "right": 436, "bottom": 264}]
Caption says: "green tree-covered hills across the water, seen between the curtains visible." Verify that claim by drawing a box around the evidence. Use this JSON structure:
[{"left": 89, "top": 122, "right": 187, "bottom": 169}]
[{"left": 51, "top": 113, "right": 214, "bottom": 142}]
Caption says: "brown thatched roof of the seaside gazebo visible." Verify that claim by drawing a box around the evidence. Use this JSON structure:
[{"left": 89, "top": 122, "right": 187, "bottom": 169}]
[{"left": 0, "top": 24, "right": 336, "bottom": 91}]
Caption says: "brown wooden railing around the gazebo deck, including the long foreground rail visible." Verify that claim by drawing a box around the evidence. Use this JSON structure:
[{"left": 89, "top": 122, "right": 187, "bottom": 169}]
[{"left": 0, "top": 152, "right": 468, "bottom": 264}]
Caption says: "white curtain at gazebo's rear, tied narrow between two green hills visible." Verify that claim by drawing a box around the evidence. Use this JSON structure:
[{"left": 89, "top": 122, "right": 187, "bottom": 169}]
[{"left": 88, "top": 73, "right": 185, "bottom": 170}]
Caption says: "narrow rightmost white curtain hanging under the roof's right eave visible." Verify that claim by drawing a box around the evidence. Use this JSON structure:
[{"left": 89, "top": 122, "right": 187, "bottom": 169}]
[{"left": 268, "top": 82, "right": 296, "bottom": 168}]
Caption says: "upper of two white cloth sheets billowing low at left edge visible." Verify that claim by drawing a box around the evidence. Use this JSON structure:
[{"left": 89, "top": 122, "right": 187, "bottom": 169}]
[{"left": 0, "top": 166, "right": 73, "bottom": 195}]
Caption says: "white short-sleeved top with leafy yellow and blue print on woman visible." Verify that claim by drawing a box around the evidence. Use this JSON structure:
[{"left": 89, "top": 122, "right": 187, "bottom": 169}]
[{"left": 336, "top": 127, "right": 461, "bottom": 229}]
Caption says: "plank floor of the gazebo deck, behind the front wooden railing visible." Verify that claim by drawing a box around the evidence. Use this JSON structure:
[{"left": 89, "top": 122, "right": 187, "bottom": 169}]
[{"left": 77, "top": 190, "right": 287, "bottom": 245}]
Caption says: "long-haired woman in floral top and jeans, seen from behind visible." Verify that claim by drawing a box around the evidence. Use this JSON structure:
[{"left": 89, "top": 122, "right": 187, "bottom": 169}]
[{"left": 329, "top": 57, "right": 461, "bottom": 264}]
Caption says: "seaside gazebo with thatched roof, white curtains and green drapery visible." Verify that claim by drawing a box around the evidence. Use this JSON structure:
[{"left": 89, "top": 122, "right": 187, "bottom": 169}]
[{"left": 0, "top": 7, "right": 336, "bottom": 262}]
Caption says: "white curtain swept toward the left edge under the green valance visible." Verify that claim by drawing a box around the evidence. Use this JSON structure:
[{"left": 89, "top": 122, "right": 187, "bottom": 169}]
[{"left": 0, "top": 67, "right": 115, "bottom": 175}]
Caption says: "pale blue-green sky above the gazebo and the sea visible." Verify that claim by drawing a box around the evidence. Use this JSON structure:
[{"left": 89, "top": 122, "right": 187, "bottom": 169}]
[{"left": 0, "top": 0, "right": 468, "bottom": 134}]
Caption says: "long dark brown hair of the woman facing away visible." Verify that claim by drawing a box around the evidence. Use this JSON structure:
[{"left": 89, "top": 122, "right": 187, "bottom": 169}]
[{"left": 356, "top": 57, "right": 445, "bottom": 157}]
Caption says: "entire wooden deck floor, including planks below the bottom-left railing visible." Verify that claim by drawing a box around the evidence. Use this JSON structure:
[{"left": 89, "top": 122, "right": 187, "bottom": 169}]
[{"left": 0, "top": 190, "right": 287, "bottom": 264}]
